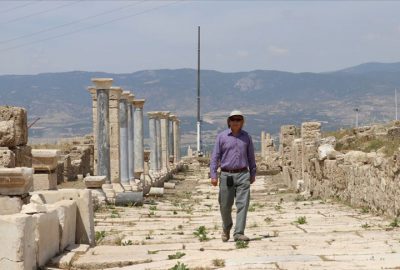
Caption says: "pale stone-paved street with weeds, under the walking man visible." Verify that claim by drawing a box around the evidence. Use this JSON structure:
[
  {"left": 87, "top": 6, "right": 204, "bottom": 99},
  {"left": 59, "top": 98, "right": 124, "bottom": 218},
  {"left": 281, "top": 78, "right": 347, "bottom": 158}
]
[{"left": 59, "top": 162, "right": 400, "bottom": 269}]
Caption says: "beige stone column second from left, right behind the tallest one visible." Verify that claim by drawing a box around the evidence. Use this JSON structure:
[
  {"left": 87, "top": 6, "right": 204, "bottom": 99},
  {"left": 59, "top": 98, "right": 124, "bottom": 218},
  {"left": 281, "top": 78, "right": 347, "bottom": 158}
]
[{"left": 108, "top": 87, "right": 122, "bottom": 183}]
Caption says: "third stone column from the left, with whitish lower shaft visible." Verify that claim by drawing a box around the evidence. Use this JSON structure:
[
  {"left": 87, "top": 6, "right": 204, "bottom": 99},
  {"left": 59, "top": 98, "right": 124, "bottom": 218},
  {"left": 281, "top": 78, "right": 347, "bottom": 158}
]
[{"left": 119, "top": 91, "right": 130, "bottom": 190}]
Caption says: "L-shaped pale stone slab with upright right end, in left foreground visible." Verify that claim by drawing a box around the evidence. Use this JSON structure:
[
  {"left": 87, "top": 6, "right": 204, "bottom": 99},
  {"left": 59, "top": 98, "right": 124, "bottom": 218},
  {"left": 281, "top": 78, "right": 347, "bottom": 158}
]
[{"left": 31, "top": 189, "right": 95, "bottom": 245}]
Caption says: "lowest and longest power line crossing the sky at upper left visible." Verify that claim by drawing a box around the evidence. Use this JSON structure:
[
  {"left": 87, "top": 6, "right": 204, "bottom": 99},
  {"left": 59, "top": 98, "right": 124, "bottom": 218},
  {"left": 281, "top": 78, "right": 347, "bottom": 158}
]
[{"left": 0, "top": 0, "right": 184, "bottom": 52}]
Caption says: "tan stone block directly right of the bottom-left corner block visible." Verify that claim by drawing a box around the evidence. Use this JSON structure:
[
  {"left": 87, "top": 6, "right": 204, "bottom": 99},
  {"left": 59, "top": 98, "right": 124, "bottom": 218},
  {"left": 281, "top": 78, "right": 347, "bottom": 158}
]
[{"left": 31, "top": 210, "right": 60, "bottom": 267}]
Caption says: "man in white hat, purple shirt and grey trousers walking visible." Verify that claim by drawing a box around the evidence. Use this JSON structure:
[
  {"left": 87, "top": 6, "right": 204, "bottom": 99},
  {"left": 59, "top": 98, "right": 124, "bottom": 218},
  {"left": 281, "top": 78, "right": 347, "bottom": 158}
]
[{"left": 210, "top": 111, "right": 256, "bottom": 242}]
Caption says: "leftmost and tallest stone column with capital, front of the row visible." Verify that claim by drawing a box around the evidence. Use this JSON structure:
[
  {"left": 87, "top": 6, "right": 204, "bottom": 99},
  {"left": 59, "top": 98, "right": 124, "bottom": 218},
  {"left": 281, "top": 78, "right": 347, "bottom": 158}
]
[{"left": 92, "top": 78, "right": 113, "bottom": 184}]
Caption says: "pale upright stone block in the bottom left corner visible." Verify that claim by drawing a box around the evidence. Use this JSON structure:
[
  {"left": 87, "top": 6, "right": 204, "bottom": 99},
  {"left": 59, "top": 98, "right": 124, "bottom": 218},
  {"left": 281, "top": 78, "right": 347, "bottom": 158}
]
[{"left": 0, "top": 214, "right": 36, "bottom": 270}]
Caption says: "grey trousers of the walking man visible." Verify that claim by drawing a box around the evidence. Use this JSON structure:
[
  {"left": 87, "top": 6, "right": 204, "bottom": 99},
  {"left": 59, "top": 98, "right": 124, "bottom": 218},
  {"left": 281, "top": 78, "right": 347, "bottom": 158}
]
[{"left": 218, "top": 172, "right": 250, "bottom": 236}]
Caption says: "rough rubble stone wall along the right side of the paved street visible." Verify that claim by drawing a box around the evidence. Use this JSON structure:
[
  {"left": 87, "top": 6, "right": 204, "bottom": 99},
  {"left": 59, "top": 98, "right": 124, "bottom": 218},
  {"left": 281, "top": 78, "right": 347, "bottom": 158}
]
[{"left": 280, "top": 122, "right": 400, "bottom": 216}]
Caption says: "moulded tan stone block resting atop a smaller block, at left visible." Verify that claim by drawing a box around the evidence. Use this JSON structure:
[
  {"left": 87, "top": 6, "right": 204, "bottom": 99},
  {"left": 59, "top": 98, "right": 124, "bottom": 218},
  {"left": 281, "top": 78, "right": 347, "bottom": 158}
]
[{"left": 32, "top": 149, "right": 60, "bottom": 172}]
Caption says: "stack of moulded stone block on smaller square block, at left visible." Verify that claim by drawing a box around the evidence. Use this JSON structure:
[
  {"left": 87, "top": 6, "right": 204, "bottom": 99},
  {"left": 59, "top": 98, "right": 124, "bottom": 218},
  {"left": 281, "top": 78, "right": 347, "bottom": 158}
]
[{"left": 32, "top": 149, "right": 60, "bottom": 190}]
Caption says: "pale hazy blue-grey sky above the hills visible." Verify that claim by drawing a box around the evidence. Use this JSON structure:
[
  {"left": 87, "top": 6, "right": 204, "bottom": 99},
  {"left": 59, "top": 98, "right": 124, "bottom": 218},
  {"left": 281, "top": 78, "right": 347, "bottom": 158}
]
[{"left": 0, "top": 0, "right": 400, "bottom": 74}]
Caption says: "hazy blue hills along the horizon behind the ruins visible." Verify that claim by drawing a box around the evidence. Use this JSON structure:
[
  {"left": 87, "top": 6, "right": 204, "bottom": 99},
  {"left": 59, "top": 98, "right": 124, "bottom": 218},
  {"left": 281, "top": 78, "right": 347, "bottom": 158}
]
[{"left": 0, "top": 63, "right": 400, "bottom": 150}]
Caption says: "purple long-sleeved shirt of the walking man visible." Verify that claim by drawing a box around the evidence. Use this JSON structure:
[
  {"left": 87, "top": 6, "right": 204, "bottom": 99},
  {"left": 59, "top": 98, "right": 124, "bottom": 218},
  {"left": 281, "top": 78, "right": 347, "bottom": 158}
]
[{"left": 210, "top": 129, "right": 256, "bottom": 179}]
